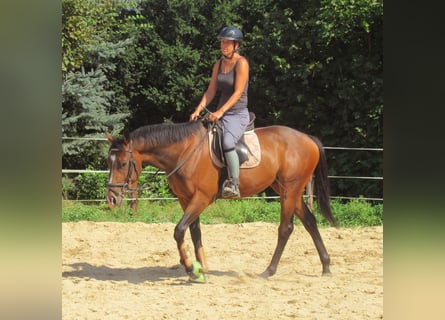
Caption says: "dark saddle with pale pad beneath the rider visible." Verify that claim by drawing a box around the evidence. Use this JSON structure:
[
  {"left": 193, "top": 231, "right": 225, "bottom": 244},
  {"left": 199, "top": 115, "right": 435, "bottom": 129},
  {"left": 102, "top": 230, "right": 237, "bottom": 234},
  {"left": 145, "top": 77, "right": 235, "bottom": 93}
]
[{"left": 209, "top": 112, "right": 261, "bottom": 169}]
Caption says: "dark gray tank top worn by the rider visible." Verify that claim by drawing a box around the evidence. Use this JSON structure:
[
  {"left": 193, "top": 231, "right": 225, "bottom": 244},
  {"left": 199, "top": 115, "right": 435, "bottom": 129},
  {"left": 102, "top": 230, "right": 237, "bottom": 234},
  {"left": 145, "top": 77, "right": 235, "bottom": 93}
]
[{"left": 216, "top": 59, "right": 249, "bottom": 110}]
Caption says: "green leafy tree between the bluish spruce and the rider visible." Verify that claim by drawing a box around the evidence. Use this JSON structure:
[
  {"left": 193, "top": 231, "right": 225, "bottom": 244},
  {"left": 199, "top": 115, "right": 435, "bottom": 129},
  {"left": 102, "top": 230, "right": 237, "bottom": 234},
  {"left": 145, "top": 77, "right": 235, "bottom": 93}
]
[{"left": 118, "top": 0, "right": 243, "bottom": 129}]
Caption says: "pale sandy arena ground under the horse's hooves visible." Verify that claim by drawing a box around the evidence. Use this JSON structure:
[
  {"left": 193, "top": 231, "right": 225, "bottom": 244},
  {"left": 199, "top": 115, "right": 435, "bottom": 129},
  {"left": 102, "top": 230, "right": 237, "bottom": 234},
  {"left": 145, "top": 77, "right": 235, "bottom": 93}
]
[{"left": 62, "top": 222, "right": 383, "bottom": 320}]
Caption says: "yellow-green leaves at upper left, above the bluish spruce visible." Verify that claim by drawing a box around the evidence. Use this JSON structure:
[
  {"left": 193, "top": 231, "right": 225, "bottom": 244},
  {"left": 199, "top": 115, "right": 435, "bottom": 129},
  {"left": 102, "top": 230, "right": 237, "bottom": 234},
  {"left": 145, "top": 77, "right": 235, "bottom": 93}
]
[{"left": 62, "top": 0, "right": 140, "bottom": 74}]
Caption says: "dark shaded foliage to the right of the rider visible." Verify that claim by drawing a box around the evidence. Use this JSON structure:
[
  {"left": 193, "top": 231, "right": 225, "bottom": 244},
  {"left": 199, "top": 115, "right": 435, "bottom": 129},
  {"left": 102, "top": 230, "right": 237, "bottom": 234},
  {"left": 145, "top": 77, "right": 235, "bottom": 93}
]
[{"left": 246, "top": 0, "right": 383, "bottom": 197}]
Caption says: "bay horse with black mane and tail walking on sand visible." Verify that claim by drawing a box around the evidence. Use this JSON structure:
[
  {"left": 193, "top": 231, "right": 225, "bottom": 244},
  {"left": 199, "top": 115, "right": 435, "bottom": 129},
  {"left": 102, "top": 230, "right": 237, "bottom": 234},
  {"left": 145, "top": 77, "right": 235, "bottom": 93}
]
[{"left": 106, "top": 121, "right": 337, "bottom": 282}]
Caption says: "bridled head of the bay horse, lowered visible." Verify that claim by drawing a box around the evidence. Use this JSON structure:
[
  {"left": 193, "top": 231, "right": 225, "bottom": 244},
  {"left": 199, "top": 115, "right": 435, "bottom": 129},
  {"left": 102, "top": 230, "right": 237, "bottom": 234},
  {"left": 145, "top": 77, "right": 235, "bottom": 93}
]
[{"left": 105, "top": 133, "right": 141, "bottom": 208}]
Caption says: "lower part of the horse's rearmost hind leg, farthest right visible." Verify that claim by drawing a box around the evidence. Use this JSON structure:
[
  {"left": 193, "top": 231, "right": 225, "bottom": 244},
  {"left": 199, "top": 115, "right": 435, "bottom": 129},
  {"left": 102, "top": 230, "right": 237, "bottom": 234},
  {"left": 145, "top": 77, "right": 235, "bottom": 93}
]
[{"left": 295, "top": 199, "right": 331, "bottom": 275}]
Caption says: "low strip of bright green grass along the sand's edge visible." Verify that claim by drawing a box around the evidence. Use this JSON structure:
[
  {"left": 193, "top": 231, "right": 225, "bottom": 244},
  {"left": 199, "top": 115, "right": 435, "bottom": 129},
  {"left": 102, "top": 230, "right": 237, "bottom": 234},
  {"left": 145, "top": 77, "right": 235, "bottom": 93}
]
[{"left": 62, "top": 199, "right": 383, "bottom": 227}]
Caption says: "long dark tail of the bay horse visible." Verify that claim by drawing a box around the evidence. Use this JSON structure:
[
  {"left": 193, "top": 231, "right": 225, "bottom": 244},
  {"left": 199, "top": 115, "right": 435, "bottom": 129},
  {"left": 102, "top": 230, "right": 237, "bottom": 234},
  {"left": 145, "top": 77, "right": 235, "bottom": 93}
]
[{"left": 311, "top": 136, "right": 338, "bottom": 227}]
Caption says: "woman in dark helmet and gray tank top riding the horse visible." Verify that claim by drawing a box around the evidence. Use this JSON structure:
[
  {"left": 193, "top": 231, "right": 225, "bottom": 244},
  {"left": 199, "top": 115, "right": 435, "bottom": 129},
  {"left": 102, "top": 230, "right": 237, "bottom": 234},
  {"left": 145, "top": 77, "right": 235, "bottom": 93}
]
[{"left": 190, "top": 26, "right": 249, "bottom": 198}]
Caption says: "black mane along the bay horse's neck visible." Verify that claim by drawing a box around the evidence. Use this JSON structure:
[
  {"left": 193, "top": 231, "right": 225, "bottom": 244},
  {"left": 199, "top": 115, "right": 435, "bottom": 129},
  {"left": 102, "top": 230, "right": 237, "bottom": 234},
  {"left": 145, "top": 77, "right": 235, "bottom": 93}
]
[{"left": 130, "top": 121, "right": 203, "bottom": 145}]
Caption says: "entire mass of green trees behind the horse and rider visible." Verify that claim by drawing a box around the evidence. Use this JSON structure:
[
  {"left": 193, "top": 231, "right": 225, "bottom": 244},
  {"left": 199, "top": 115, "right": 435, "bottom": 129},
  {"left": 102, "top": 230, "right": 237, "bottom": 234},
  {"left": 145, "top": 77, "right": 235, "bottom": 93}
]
[{"left": 62, "top": 0, "right": 383, "bottom": 198}]
